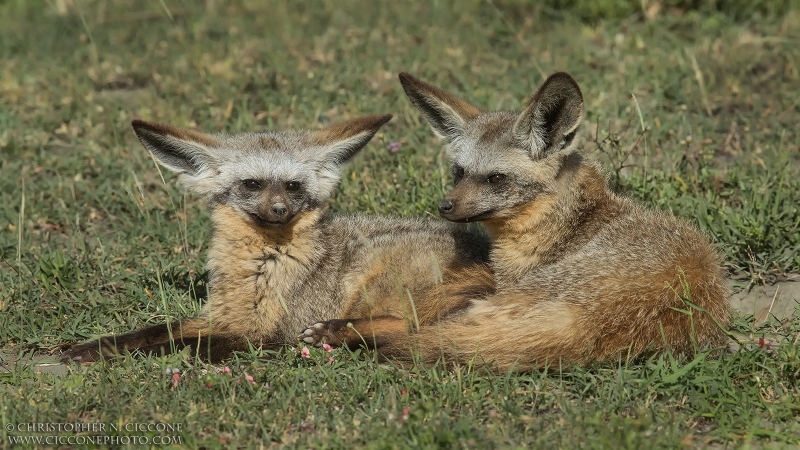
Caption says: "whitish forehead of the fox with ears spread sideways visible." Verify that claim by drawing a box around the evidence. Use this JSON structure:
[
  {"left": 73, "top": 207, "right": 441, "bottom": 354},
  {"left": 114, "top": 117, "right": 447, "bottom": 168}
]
[{"left": 216, "top": 133, "right": 321, "bottom": 180}]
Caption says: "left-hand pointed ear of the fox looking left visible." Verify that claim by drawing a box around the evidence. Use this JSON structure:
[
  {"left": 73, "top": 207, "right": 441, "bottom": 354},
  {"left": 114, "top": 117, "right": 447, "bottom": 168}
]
[{"left": 399, "top": 72, "right": 481, "bottom": 142}]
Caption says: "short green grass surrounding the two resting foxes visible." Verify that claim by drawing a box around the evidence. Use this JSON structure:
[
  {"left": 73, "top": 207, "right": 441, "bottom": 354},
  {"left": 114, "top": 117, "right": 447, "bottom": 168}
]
[{"left": 0, "top": 0, "right": 800, "bottom": 448}]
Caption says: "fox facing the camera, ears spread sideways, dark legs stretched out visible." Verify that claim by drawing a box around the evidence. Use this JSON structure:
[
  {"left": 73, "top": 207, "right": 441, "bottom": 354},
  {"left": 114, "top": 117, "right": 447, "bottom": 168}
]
[{"left": 62, "top": 115, "right": 494, "bottom": 362}]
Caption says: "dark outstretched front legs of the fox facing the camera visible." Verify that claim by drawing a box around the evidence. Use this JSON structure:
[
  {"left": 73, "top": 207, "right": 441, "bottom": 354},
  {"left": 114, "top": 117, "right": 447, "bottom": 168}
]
[{"left": 61, "top": 317, "right": 248, "bottom": 362}]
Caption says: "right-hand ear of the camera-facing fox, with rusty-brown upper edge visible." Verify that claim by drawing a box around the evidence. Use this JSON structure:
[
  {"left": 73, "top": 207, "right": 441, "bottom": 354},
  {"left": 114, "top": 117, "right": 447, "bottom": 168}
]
[{"left": 311, "top": 114, "right": 392, "bottom": 165}]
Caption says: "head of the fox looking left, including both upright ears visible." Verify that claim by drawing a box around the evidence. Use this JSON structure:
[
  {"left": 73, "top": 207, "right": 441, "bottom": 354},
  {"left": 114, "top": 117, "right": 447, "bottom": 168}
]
[{"left": 400, "top": 73, "right": 583, "bottom": 222}]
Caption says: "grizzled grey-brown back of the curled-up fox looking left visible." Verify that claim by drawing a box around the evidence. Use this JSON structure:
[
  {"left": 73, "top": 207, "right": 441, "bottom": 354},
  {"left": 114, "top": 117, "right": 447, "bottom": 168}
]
[{"left": 519, "top": 193, "right": 722, "bottom": 307}]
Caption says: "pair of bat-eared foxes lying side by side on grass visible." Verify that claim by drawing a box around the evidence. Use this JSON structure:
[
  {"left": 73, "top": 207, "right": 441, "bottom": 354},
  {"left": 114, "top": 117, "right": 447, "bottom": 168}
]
[{"left": 63, "top": 73, "right": 729, "bottom": 371}]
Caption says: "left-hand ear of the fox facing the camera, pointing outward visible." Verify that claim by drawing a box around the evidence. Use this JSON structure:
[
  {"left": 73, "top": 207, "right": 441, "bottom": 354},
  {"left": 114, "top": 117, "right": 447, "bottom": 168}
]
[{"left": 131, "top": 120, "right": 219, "bottom": 177}]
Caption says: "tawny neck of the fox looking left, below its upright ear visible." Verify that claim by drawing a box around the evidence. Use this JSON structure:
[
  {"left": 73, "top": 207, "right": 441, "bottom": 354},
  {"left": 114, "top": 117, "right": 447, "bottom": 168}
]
[{"left": 484, "top": 163, "right": 615, "bottom": 288}]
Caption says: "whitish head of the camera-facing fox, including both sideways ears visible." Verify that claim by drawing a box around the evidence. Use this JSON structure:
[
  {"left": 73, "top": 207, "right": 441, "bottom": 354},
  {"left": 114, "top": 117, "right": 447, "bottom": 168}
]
[{"left": 132, "top": 115, "right": 392, "bottom": 227}]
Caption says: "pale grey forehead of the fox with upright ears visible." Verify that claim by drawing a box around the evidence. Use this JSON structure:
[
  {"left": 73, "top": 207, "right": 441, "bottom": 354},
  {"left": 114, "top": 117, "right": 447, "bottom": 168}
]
[{"left": 448, "top": 111, "right": 531, "bottom": 174}]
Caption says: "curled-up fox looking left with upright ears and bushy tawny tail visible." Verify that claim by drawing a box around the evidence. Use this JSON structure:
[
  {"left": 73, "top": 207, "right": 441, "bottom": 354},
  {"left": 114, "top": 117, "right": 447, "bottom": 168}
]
[{"left": 307, "top": 73, "right": 728, "bottom": 370}]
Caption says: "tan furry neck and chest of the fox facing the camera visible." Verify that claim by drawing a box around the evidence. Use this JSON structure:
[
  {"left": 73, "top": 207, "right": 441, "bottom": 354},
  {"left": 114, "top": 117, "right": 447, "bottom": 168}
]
[{"left": 206, "top": 205, "right": 327, "bottom": 339}]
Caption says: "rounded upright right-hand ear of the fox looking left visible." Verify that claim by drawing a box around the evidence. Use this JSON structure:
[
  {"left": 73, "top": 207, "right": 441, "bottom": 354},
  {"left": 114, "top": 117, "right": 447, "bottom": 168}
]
[{"left": 513, "top": 72, "right": 583, "bottom": 159}]
